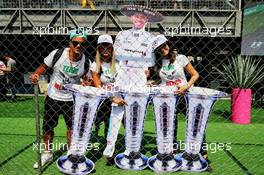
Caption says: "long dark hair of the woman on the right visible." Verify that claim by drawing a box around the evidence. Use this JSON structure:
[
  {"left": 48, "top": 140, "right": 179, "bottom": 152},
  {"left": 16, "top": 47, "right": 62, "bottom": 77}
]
[{"left": 154, "top": 41, "right": 177, "bottom": 84}]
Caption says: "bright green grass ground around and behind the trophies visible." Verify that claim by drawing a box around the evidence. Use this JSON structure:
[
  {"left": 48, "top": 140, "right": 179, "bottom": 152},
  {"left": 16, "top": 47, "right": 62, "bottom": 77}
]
[{"left": 0, "top": 97, "right": 264, "bottom": 175}]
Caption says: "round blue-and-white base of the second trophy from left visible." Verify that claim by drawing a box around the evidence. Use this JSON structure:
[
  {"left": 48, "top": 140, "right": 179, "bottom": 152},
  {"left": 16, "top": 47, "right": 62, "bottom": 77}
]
[{"left": 115, "top": 152, "right": 148, "bottom": 170}]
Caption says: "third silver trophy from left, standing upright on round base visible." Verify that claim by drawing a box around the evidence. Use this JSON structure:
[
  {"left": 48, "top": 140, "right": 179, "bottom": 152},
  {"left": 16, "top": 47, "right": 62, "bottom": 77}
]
[{"left": 148, "top": 86, "right": 182, "bottom": 173}]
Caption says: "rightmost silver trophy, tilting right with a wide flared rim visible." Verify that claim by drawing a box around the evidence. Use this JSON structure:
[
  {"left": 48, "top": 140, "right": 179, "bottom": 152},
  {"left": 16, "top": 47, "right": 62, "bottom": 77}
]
[{"left": 181, "top": 87, "right": 227, "bottom": 172}]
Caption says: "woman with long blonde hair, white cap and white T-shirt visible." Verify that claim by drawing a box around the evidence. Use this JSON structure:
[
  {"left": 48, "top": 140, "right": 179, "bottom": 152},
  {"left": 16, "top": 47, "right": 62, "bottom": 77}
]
[{"left": 90, "top": 35, "right": 117, "bottom": 137}]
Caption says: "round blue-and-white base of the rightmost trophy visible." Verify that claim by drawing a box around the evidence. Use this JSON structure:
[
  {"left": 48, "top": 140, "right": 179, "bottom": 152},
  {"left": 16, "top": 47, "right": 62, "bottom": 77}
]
[{"left": 180, "top": 152, "right": 208, "bottom": 172}]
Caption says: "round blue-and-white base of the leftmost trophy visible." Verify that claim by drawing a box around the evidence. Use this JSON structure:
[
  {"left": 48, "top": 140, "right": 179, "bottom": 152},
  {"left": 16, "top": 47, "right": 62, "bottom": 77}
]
[{"left": 57, "top": 154, "right": 94, "bottom": 175}]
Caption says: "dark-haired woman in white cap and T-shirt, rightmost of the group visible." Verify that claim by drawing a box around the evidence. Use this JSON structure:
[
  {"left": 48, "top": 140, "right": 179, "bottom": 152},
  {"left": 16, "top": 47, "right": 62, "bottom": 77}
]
[{"left": 153, "top": 35, "right": 212, "bottom": 159}]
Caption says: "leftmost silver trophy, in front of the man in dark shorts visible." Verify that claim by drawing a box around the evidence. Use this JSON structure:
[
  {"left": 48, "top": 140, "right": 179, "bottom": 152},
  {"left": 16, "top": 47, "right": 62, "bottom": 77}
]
[{"left": 57, "top": 84, "right": 106, "bottom": 175}]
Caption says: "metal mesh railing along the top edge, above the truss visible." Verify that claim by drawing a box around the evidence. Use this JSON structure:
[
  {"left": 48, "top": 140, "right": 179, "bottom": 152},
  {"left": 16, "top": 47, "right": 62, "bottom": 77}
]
[{"left": 0, "top": 0, "right": 241, "bottom": 10}]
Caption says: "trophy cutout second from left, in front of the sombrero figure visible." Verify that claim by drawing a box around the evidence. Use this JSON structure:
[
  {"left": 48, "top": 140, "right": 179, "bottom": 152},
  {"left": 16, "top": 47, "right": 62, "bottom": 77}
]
[{"left": 115, "top": 87, "right": 150, "bottom": 170}]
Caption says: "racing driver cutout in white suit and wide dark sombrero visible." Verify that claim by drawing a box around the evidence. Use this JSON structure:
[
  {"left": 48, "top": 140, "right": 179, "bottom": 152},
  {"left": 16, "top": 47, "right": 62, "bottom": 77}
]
[{"left": 103, "top": 5, "right": 163, "bottom": 157}]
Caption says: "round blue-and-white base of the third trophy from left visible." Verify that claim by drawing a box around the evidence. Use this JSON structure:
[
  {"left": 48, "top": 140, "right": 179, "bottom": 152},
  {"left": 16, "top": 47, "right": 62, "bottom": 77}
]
[{"left": 148, "top": 154, "right": 182, "bottom": 173}]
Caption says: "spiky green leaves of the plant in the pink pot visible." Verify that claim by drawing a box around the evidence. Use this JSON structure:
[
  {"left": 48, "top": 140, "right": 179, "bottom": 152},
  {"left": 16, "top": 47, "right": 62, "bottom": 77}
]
[{"left": 217, "top": 56, "right": 264, "bottom": 89}]
